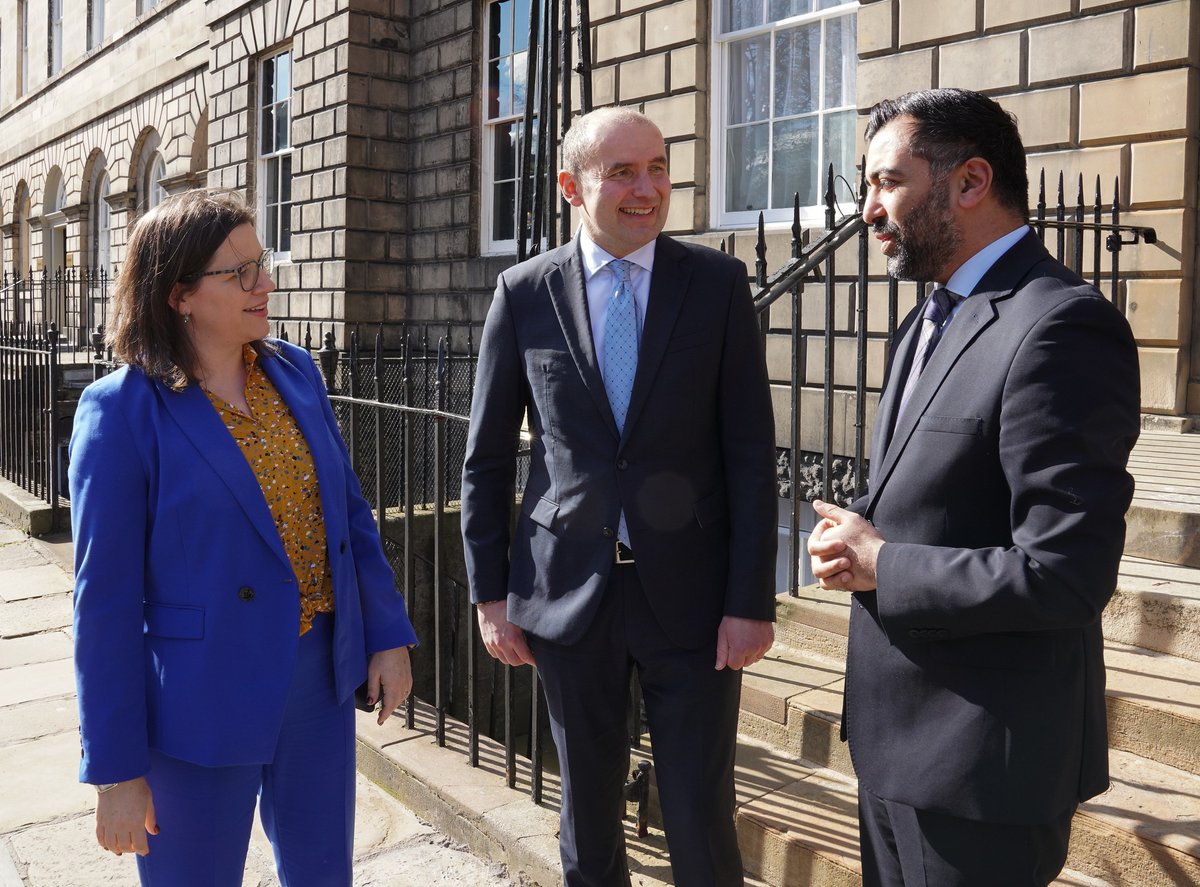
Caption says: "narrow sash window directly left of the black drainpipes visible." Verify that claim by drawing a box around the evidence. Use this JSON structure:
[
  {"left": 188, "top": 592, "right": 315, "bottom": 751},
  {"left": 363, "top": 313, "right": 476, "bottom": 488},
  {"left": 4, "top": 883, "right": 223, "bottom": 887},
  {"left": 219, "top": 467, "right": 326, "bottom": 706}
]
[{"left": 482, "top": 0, "right": 530, "bottom": 252}]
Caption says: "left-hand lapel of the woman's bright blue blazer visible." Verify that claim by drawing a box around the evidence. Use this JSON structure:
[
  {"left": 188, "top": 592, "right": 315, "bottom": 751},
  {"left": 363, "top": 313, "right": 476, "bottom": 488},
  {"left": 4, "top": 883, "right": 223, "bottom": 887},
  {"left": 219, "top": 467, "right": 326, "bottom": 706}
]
[{"left": 158, "top": 383, "right": 288, "bottom": 563}]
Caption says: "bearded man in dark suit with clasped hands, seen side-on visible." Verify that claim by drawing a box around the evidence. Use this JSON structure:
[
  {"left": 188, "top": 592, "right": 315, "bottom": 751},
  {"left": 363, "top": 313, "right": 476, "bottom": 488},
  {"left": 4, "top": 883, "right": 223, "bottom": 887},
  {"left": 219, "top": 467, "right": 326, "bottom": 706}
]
[{"left": 809, "top": 89, "right": 1139, "bottom": 887}]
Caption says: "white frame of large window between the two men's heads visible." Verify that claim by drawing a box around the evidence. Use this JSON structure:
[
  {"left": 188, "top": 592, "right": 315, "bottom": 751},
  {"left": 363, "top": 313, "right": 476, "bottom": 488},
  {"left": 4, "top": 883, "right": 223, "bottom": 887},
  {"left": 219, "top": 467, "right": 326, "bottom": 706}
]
[{"left": 709, "top": 0, "right": 859, "bottom": 228}]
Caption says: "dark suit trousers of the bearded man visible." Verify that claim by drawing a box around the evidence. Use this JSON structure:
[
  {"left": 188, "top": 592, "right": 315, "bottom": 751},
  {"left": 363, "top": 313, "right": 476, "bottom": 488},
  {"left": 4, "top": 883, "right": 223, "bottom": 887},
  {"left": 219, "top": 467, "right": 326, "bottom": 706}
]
[{"left": 858, "top": 786, "right": 1075, "bottom": 887}]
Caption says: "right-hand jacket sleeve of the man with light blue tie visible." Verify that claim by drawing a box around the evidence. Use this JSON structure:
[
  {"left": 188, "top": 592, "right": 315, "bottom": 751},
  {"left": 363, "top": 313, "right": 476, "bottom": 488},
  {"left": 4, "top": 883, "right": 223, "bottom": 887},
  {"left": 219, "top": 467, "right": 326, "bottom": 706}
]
[{"left": 718, "top": 263, "right": 779, "bottom": 621}]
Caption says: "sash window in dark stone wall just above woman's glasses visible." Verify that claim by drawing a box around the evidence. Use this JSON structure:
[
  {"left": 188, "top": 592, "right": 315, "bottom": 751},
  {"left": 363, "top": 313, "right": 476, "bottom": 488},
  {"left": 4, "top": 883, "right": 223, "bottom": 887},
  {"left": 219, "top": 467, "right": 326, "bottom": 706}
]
[{"left": 258, "top": 49, "right": 292, "bottom": 260}]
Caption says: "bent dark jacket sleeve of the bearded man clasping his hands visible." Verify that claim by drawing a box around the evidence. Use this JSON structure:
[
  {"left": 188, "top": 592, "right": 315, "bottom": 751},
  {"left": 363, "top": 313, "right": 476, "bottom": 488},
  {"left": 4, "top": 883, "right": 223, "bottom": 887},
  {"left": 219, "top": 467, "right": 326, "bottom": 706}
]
[{"left": 877, "top": 296, "right": 1140, "bottom": 637}]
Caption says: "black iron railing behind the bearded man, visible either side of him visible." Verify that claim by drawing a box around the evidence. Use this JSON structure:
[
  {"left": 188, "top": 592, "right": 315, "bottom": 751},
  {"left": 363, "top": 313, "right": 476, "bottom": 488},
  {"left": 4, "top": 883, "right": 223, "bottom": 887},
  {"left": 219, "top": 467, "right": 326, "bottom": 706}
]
[{"left": 755, "top": 167, "right": 1157, "bottom": 595}]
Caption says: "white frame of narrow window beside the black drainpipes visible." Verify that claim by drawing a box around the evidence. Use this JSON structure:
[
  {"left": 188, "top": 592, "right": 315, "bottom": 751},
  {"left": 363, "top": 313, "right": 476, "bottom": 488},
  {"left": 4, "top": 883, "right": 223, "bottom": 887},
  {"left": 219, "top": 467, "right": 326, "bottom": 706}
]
[{"left": 479, "top": 0, "right": 536, "bottom": 256}]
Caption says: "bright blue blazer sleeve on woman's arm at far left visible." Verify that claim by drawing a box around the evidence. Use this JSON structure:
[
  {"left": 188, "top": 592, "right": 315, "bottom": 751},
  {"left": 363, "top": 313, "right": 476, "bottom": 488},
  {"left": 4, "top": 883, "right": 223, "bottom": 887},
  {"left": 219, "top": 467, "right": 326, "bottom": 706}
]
[{"left": 70, "top": 381, "right": 150, "bottom": 783}]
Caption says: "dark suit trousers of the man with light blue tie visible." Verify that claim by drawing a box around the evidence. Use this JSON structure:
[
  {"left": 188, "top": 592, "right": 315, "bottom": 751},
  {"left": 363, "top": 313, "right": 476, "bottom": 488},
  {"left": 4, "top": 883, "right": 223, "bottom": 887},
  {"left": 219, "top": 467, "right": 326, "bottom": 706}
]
[{"left": 529, "top": 565, "right": 744, "bottom": 887}]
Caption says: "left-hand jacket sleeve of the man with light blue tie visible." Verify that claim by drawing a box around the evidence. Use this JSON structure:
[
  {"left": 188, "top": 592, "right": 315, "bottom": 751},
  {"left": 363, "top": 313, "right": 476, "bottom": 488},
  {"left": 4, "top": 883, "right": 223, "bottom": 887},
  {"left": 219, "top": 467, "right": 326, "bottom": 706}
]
[{"left": 462, "top": 275, "right": 527, "bottom": 604}]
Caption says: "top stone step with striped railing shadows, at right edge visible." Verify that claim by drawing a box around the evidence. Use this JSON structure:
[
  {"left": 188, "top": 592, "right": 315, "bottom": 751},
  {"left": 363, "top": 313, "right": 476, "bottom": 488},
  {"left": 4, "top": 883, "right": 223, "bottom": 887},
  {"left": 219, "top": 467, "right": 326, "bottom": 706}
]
[{"left": 1126, "top": 431, "right": 1200, "bottom": 567}]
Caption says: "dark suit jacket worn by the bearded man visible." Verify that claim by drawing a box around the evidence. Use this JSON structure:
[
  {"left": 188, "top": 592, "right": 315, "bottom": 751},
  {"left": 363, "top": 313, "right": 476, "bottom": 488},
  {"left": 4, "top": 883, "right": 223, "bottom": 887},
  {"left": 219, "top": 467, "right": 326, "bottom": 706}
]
[{"left": 844, "top": 233, "right": 1140, "bottom": 823}]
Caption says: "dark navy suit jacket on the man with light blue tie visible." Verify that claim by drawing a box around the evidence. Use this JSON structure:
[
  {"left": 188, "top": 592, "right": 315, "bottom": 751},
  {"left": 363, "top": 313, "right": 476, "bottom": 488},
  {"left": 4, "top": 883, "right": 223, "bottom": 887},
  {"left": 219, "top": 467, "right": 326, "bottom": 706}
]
[{"left": 462, "top": 236, "right": 776, "bottom": 648}]
